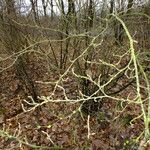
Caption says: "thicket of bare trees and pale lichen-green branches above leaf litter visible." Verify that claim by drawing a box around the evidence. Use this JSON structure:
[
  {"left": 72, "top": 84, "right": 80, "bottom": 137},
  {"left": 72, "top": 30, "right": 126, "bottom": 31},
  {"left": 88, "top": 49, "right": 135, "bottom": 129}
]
[{"left": 0, "top": 0, "right": 150, "bottom": 149}]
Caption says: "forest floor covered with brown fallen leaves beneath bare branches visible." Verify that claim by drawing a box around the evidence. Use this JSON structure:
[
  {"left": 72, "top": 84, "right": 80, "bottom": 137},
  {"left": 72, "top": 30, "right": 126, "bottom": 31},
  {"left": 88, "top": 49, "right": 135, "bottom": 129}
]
[{"left": 0, "top": 53, "right": 143, "bottom": 150}]
